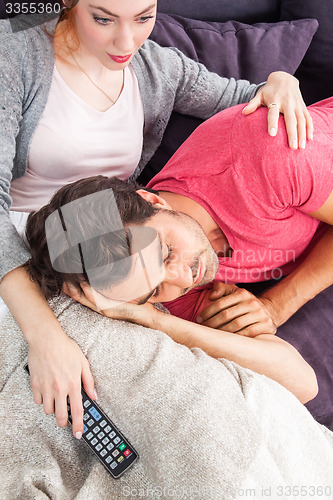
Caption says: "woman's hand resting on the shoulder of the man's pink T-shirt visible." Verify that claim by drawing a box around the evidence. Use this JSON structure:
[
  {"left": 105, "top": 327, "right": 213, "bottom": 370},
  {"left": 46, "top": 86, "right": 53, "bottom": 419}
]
[{"left": 243, "top": 71, "right": 313, "bottom": 149}]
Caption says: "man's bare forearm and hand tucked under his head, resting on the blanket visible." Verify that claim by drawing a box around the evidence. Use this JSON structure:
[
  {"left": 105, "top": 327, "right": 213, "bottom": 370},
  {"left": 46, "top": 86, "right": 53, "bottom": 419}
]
[{"left": 64, "top": 285, "right": 318, "bottom": 403}]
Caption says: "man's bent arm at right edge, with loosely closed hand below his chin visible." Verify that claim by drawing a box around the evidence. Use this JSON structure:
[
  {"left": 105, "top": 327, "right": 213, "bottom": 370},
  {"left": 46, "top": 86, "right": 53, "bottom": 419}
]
[{"left": 197, "top": 192, "right": 333, "bottom": 337}]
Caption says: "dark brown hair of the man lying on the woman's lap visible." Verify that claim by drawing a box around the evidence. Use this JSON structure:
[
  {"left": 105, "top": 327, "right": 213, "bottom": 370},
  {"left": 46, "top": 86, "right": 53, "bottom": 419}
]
[{"left": 26, "top": 175, "right": 159, "bottom": 299}]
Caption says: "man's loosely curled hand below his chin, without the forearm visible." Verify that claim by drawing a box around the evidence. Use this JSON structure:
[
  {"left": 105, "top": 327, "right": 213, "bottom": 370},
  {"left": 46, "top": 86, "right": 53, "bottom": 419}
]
[{"left": 197, "top": 282, "right": 276, "bottom": 337}]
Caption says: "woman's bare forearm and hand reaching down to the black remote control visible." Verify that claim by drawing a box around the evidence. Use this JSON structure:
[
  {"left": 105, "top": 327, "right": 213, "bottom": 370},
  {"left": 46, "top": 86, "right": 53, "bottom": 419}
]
[{"left": 0, "top": 267, "right": 96, "bottom": 438}]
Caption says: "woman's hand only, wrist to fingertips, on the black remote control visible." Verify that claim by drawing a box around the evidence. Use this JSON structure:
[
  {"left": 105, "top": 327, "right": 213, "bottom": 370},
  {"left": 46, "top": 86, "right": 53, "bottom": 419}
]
[{"left": 28, "top": 325, "right": 96, "bottom": 439}]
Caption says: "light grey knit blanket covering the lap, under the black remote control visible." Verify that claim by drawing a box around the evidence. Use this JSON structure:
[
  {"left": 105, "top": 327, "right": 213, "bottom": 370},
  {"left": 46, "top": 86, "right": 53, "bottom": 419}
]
[{"left": 0, "top": 298, "right": 333, "bottom": 500}]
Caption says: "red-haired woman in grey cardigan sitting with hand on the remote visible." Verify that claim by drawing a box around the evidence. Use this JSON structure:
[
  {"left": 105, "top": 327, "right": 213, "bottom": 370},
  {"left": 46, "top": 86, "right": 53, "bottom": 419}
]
[{"left": 0, "top": 0, "right": 312, "bottom": 437}]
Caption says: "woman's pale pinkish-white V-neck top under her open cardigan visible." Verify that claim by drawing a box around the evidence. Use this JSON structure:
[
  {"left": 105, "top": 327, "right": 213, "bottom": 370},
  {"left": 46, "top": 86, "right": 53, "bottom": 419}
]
[{"left": 10, "top": 66, "right": 144, "bottom": 212}]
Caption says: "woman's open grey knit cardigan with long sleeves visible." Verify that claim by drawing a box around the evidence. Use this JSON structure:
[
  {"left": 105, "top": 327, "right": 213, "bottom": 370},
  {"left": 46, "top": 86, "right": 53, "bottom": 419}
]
[{"left": 0, "top": 19, "right": 262, "bottom": 279}]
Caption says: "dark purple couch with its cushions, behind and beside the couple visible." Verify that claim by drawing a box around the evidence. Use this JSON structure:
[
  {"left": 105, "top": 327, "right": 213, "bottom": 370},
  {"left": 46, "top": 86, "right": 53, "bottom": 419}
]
[{"left": 0, "top": 0, "right": 333, "bottom": 430}]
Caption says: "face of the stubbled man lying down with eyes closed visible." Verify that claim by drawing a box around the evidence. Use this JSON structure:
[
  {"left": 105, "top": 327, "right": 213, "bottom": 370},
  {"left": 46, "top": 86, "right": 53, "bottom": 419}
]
[{"left": 99, "top": 209, "right": 219, "bottom": 303}]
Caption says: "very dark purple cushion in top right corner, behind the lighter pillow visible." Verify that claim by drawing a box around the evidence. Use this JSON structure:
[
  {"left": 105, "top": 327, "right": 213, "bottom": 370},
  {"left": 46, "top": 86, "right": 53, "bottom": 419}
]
[{"left": 281, "top": 0, "right": 333, "bottom": 104}]
